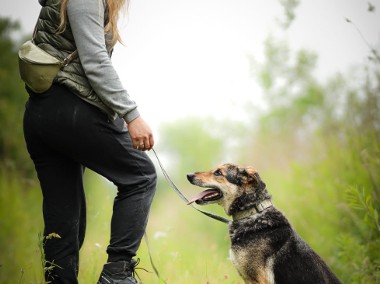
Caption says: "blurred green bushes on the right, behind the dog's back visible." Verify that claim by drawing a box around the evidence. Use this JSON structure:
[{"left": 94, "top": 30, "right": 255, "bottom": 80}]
[{"left": 251, "top": 34, "right": 380, "bottom": 283}]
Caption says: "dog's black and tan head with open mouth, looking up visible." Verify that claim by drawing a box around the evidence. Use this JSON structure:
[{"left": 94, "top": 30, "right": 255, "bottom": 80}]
[{"left": 187, "top": 164, "right": 271, "bottom": 215}]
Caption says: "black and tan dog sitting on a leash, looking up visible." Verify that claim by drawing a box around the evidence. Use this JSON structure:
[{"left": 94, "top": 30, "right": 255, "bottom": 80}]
[{"left": 187, "top": 164, "right": 341, "bottom": 284}]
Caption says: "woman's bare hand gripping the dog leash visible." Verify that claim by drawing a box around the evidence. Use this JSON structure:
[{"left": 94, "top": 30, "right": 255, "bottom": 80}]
[{"left": 127, "top": 116, "right": 154, "bottom": 151}]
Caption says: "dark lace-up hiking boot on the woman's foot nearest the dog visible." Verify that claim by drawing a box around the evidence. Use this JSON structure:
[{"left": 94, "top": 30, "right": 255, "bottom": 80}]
[{"left": 98, "top": 259, "right": 139, "bottom": 284}]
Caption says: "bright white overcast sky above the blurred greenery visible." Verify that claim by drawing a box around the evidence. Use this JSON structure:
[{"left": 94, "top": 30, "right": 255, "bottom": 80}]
[{"left": 0, "top": 0, "right": 380, "bottom": 131}]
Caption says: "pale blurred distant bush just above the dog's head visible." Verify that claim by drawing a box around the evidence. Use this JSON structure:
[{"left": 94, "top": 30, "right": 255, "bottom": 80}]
[{"left": 158, "top": 117, "right": 246, "bottom": 175}]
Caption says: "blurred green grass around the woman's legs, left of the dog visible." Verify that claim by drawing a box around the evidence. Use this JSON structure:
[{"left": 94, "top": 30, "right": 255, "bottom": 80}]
[{"left": 0, "top": 168, "right": 243, "bottom": 284}]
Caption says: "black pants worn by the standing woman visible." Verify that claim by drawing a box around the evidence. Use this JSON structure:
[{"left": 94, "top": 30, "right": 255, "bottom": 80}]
[{"left": 24, "top": 85, "right": 156, "bottom": 283}]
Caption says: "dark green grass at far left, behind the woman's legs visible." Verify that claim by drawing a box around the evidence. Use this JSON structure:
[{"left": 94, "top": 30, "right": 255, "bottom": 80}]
[{"left": 0, "top": 167, "right": 43, "bottom": 284}]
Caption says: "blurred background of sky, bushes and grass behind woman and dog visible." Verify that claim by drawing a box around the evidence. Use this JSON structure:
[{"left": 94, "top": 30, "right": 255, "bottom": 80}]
[{"left": 0, "top": 0, "right": 380, "bottom": 284}]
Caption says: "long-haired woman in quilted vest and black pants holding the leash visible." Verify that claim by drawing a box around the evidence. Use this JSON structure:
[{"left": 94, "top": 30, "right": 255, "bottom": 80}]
[{"left": 24, "top": 0, "right": 156, "bottom": 284}]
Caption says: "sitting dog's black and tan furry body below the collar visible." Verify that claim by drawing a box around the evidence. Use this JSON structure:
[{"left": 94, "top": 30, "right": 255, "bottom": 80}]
[{"left": 230, "top": 207, "right": 340, "bottom": 284}]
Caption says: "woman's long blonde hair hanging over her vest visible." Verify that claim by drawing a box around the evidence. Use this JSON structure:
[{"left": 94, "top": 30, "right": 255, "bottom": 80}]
[{"left": 58, "top": 0, "right": 128, "bottom": 46}]
